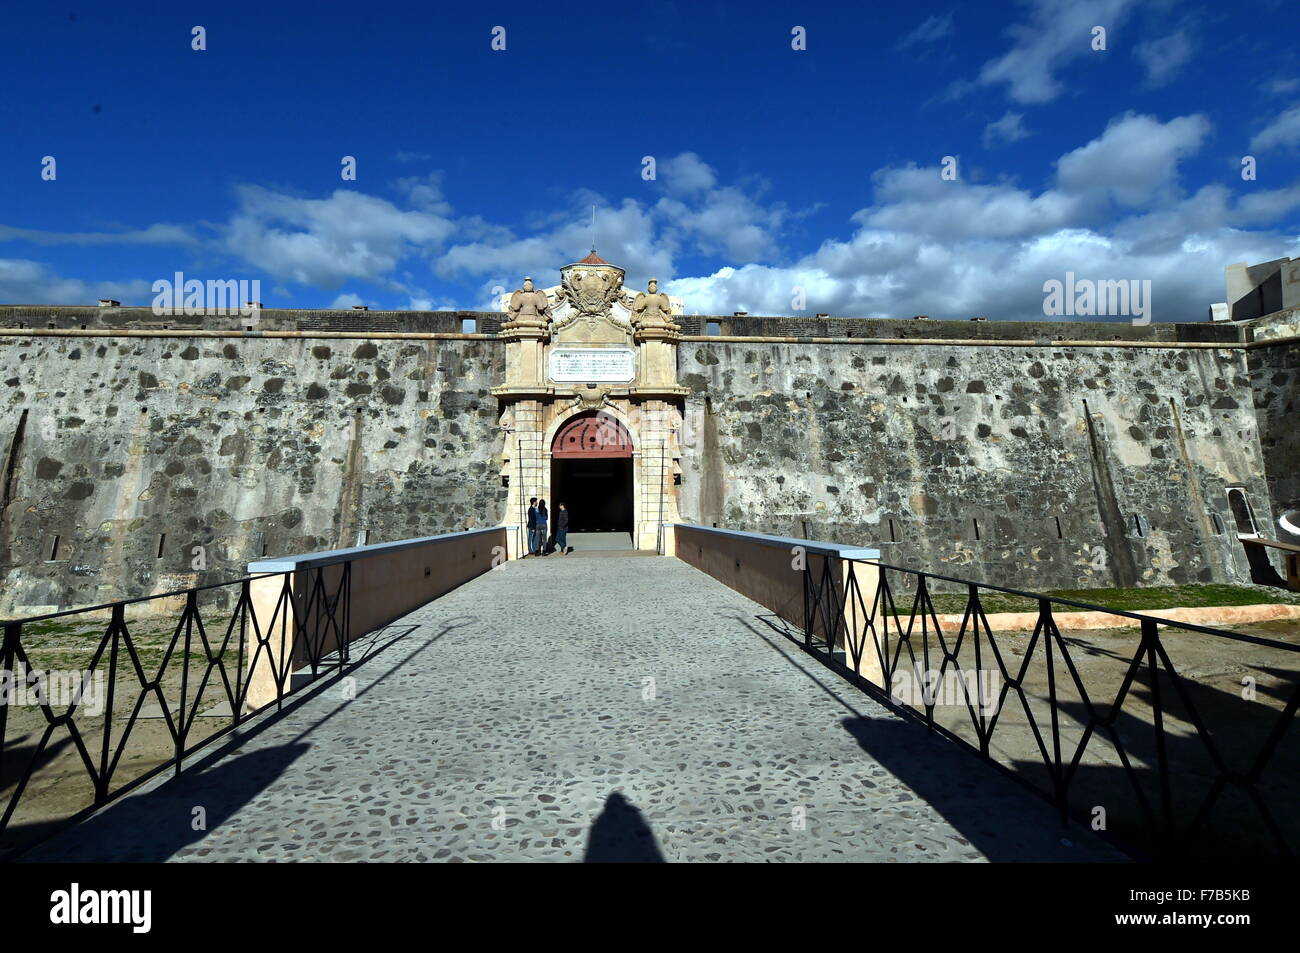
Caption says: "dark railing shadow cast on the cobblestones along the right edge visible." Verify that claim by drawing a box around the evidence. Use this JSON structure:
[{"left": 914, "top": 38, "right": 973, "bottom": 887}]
[{"left": 732, "top": 614, "right": 1126, "bottom": 862}]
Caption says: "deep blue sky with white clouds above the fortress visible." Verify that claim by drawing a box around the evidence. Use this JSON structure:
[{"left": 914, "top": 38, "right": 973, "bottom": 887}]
[{"left": 0, "top": 0, "right": 1300, "bottom": 321}]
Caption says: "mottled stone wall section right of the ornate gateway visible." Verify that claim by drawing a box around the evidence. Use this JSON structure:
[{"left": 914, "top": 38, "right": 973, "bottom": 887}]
[{"left": 679, "top": 342, "right": 1268, "bottom": 589}]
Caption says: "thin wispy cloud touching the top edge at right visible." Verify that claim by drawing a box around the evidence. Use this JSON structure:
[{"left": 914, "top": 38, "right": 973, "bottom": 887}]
[{"left": 979, "top": 0, "right": 1135, "bottom": 104}]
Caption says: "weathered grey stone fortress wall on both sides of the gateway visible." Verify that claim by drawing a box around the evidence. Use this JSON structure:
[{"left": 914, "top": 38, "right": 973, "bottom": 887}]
[{"left": 0, "top": 297, "right": 1300, "bottom": 615}]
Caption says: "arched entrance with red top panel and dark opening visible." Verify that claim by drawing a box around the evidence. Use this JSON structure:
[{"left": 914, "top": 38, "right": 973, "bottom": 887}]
[{"left": 551, "top": 411, "right": 634, "bottom": 534}]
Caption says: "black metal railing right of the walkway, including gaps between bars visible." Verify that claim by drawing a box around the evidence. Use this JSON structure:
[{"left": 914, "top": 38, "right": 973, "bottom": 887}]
[{"left": 802, "top": 559, "right": 1300, "bottom": 858}]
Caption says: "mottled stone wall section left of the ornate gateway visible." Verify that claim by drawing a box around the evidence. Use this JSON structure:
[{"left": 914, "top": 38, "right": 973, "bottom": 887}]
[{"left": 0, "top": 324, "right": 506, "bottom": 614}]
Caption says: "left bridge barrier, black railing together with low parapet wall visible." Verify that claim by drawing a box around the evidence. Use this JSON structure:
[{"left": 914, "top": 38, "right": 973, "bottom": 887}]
[{"left": 0, "top": 527, "right": 506, "bottom": 852}]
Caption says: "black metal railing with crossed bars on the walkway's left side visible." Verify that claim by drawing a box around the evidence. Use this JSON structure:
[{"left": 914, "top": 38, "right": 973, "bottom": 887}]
[{"left": 0, "top": 562, "right": 352, "bottom": 853}]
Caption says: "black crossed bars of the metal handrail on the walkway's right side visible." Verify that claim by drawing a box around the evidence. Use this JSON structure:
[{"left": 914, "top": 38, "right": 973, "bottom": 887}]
[{"left": 802, "top": 556, "right": 1300, "bottom": 857}]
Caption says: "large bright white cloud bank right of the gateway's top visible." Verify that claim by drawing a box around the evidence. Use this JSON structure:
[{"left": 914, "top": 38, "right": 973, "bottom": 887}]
[{"left": 655, "top": 114, "right": 1300, "bottom": 321}]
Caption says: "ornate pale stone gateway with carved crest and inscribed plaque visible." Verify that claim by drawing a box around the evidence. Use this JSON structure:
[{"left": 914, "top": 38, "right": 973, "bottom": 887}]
[{"left": 493, "top": 250, "right": 686, "bottom": 550}]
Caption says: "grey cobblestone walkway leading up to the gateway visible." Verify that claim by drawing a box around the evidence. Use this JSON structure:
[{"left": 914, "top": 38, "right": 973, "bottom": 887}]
[{"left": 20, "top": 555, "right": 1122, "bottom": 862}]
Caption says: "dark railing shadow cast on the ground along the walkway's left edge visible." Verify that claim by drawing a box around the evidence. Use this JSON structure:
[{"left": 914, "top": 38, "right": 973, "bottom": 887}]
[{"left": 4, "top": 620, "right": 468, "bottom": 862}]
